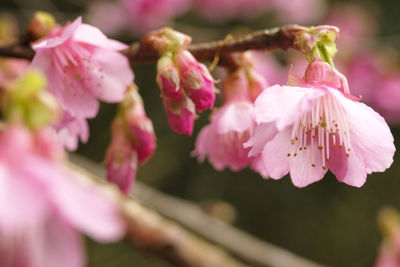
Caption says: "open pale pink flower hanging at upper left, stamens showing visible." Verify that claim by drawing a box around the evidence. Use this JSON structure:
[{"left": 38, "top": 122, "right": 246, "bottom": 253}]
[{"left": 32, "top": 17, "right": 133, "bottom": 149}]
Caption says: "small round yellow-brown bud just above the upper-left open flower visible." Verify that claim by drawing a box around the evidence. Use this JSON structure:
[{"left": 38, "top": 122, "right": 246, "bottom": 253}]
[{"left": 29, "top": 11, "right": 57, "bottom": 39}]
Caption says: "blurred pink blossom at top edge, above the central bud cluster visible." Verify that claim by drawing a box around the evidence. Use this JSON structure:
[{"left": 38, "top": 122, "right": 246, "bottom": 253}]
[{"left": 121, "top": 0, "right": 191, "bottom": 35}]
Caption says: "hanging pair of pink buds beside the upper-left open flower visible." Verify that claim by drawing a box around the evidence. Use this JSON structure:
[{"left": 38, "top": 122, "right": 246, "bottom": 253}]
[{"left": 106, "top": 85, "right": 156, "bottom": 193}]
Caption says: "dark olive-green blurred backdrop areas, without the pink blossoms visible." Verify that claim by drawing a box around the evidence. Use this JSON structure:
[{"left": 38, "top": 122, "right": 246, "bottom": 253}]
[{"left": 0, "top": 0, "right": 400, "bottom": 267}]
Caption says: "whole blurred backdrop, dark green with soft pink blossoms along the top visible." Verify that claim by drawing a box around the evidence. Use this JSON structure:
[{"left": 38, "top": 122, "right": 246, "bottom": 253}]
[{"left": 0, "top": 0, "right": 400, "bottom": 267}]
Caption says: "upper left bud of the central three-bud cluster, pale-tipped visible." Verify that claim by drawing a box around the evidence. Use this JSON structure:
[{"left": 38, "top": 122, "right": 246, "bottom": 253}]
[{"left": 157, "top": 56, "right": 182, "bottom": 99}]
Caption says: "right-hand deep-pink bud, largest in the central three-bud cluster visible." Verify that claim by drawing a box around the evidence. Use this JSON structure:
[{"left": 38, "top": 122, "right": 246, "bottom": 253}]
[{"left": 175, "top": 50, "right": 215, "bottom": 112}]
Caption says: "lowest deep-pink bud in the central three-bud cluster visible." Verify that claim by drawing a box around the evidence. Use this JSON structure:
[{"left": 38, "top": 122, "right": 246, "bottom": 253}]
[{"left": 164, "top": 97, "right": 195, "bottom": 135}]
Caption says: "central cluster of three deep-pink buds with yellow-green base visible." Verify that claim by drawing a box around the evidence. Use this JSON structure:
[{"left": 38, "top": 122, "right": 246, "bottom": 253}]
[{"left": 143, "top": 28, "right": 215, "bottom": 135}]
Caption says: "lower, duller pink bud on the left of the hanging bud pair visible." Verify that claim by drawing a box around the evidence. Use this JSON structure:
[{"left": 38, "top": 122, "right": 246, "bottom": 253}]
[{"left": 106, "top": 118, "right": 138, "bottom": 193}]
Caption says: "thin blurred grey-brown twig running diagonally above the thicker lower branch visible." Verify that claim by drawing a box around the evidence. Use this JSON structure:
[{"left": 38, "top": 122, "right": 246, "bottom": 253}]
[{"left": 70, "top": 155, "right": 322, "bottom": 267}]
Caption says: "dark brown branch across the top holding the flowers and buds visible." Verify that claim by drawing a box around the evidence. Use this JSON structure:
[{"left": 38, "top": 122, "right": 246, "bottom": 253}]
[{"left": 0, "top": 25, "right": 305, "bottom": 65}]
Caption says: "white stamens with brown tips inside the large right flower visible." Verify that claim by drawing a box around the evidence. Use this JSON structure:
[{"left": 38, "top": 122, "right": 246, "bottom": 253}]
[{"left": 288, "top": 94, "right": 351, "bottom": 170}]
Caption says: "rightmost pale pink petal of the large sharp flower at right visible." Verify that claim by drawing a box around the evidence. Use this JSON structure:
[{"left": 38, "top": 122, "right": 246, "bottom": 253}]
[{"left": 329, "top": 89, "right": 395, "bottom": 173}]
